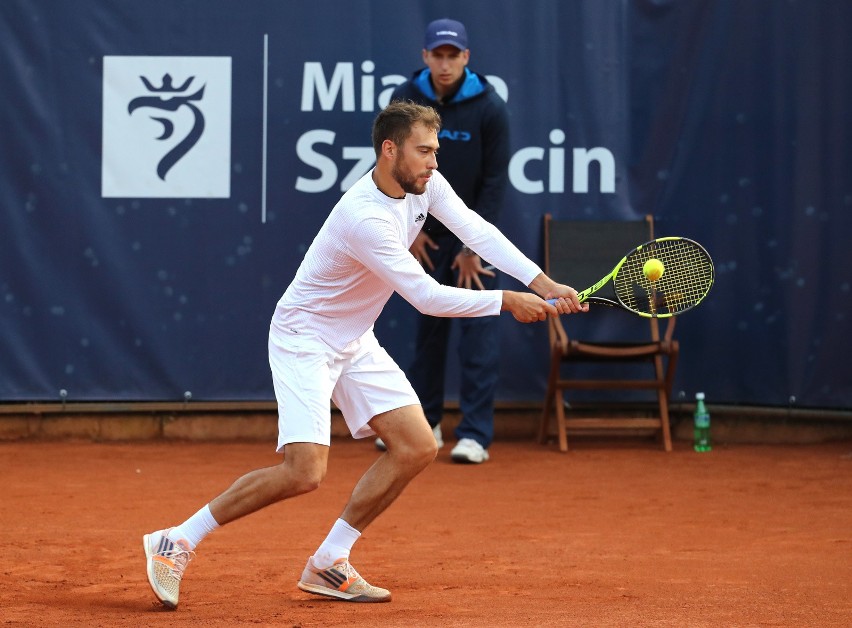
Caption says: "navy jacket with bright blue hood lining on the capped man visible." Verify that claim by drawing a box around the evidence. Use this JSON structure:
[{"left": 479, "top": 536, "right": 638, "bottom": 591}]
[{"left": 391, "top": 68, "right": 509, "bottom": 237}]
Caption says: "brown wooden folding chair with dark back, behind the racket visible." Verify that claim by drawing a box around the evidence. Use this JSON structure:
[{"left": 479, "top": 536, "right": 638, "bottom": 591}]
[{"left": 538, "top": 214, "right": 679, "bottom": 451}]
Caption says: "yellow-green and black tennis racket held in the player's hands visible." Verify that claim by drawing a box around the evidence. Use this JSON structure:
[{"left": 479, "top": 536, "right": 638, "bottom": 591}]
[{"left": 548, "top": 237, "right": 714, "bottom": 318}]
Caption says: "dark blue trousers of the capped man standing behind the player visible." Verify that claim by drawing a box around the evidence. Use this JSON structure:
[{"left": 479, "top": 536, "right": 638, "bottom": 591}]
[{"left": 407, "top": 236, "right": 500, "bottom": 448}]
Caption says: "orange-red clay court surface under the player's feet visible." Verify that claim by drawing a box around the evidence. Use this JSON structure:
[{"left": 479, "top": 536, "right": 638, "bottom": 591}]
[{"left": 0, "top": 439, "right": 852, "bottom": 627}]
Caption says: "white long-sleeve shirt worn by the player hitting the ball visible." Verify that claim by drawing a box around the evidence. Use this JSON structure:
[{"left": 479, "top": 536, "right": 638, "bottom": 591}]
[{"left": 272, "top": 171, "right": 541, "bottom": 351}]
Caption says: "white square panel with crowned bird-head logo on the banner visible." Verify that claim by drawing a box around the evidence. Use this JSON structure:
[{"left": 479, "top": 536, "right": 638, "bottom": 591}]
[{"left": 101, "top": 56, "right": 231, "bottom": 198}]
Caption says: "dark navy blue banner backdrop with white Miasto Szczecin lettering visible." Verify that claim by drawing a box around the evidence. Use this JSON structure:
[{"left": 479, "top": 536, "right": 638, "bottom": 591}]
[{"left": 0, "top": 0, "right": 852, "bottom": 408}]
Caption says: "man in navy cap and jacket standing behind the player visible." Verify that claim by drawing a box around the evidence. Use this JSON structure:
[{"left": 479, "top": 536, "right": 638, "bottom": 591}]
[{"left": 376, "top": 19, "right": 509, "bottom": 464}]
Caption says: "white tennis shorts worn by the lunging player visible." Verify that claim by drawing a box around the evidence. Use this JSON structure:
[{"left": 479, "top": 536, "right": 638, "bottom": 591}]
[{"left": 269, "top": 325, "right": 420, "bottom": 452}]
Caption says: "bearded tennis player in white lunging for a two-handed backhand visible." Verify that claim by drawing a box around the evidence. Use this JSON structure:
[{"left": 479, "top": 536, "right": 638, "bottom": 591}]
[{"left": 143, "top": 102, "right": 588, "bottom": 608}]
